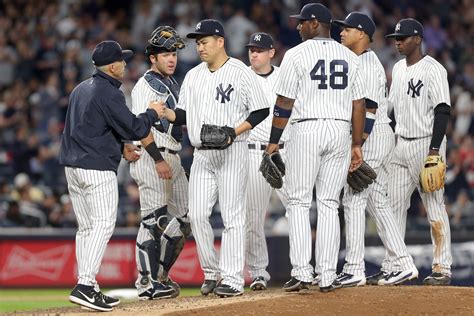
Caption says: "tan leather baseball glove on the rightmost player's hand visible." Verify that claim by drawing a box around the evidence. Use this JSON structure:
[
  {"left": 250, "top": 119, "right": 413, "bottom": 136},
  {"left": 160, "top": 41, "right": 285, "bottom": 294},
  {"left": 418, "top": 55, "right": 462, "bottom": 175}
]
[{"left": 420, "top": 155, "right": 446, "bottom": 192}]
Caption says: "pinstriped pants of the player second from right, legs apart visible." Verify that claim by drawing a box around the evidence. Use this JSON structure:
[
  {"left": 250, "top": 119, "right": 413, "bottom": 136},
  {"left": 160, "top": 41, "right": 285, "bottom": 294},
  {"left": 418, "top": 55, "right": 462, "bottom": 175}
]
[{"left": 343, "top": 124, "right": 414, "bottom": 275}]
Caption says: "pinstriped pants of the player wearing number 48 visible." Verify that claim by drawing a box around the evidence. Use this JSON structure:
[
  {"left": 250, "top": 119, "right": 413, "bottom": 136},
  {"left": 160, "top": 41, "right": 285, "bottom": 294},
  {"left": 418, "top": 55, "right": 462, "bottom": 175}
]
[{"left": 286, "top": 119, "right": 350, "bottom": 286}]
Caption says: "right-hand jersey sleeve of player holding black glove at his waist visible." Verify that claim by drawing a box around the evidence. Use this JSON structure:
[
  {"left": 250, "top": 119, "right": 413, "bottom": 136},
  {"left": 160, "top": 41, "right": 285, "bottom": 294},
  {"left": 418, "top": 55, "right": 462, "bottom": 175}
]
[{"left": 242, "top": 68, "right": 270, "bottom": 112}]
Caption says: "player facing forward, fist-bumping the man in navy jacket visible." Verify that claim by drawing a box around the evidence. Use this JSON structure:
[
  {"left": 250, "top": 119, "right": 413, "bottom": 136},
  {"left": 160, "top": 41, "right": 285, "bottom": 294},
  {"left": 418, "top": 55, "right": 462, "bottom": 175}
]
[{"left": 159, "top": 19, "right": 269, "bottom": 297}]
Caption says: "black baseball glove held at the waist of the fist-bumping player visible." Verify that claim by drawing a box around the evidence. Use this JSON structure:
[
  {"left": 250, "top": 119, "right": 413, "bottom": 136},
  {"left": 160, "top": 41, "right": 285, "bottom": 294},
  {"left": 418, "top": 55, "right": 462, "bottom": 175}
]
[{"left": 201, "top": 124, "right": 237, "bottom": 149}]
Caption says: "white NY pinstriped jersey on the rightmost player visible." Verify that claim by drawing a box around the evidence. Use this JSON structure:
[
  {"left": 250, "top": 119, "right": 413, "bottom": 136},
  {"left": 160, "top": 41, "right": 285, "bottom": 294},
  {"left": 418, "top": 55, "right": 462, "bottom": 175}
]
[{"left": 389, "top": 56, "right": 451, "bottom": 138}]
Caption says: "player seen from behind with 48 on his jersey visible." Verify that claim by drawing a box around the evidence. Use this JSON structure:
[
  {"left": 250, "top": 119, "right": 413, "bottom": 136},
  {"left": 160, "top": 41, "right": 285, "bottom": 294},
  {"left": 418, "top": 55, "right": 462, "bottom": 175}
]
[{"left": 266, "top": 3, "right": 365, "bottom": 292}]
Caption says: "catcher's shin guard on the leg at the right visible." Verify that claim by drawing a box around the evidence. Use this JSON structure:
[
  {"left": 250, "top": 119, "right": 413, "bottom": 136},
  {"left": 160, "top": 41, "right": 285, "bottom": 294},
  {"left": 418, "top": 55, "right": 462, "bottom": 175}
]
[{"left": 159, "top": 217, "right": 191, "bottom": 280}]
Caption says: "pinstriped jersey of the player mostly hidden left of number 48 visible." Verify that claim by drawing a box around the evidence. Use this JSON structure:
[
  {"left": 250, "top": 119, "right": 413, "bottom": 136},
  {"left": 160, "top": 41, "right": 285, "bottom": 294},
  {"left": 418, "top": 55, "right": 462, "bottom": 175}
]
[{"left": 248, "top": 66, "right": 291, "bottom": 143}]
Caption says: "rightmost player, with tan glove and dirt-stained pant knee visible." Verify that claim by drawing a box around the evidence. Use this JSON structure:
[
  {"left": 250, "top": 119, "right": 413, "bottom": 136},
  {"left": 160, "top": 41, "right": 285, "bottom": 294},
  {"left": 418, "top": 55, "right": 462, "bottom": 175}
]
[{"left": 387, "top": 19, "right": 452, "bottom": 285}]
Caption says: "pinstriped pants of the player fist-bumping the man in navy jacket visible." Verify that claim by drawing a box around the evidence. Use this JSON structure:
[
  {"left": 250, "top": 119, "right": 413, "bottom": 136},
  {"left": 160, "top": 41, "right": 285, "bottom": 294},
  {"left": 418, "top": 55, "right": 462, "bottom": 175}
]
[{"left": 188, "top": 142, "right": 248, "bottom": 290}]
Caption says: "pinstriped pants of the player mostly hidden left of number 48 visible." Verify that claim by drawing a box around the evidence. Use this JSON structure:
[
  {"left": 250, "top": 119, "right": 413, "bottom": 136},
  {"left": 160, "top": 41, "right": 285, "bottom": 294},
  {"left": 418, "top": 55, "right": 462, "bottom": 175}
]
[{"left": 245, "top": 143, "right": 288, "bottom": 281}]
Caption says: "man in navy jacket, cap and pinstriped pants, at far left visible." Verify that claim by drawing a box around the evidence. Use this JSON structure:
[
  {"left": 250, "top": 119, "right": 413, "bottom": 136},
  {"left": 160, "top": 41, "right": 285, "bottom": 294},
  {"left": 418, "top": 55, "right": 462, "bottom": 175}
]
[{"left": 59, "top": 41, "right": 164, "bottom": 312}]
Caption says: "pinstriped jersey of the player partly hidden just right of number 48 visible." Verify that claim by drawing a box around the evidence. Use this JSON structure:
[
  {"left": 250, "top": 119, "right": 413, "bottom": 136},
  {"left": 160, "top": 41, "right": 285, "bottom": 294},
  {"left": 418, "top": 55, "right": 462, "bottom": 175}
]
[{"left": 359, "top": 50, "right": 391, "bottom": 125}]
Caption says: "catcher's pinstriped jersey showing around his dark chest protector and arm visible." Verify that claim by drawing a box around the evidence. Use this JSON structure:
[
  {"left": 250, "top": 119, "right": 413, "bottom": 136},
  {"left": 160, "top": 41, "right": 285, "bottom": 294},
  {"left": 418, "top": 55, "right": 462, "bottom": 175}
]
[{"left": 131, "top": 70, "right": 181, "bottom": 151}]
